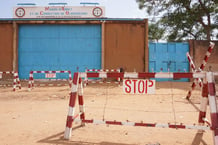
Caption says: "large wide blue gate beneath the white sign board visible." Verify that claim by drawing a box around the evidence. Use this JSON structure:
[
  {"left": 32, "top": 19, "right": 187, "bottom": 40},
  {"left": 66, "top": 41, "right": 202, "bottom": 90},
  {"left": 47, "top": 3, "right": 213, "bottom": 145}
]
[{"left": 18, "top": 24, "right": 101, "bottom": 79}]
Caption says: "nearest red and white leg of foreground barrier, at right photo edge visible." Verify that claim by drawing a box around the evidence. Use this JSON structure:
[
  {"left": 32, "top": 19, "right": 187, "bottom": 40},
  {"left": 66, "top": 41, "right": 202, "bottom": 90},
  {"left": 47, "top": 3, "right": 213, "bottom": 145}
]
[{"left": 207, "top": 72, "right": 218, "bottom": 145}]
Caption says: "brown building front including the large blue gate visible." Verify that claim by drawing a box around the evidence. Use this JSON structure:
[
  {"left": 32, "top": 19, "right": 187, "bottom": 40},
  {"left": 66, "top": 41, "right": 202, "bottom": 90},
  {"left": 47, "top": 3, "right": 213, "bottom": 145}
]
[{"left": 0, "top": 18, "right": 148, "bottom": 79}]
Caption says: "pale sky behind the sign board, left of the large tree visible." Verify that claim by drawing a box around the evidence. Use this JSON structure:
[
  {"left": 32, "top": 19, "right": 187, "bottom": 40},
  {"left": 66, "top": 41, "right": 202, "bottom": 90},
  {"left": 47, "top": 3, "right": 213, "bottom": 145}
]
[{"left": 0, "top": 0, "right": 147, "bottom": 18}]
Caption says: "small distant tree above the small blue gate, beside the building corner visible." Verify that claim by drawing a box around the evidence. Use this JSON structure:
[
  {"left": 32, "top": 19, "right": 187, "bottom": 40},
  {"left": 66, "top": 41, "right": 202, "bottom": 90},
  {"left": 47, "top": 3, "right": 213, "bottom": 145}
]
[{"left": 148, "top": 23, "right": 165, "bottom": 42}]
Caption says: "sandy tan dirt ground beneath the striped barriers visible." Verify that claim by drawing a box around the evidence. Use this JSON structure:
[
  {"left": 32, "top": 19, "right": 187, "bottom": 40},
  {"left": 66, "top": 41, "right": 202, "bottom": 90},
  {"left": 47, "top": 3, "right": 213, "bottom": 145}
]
[{"left": 0, "top": 82, "right": 217, "bottom": 145}]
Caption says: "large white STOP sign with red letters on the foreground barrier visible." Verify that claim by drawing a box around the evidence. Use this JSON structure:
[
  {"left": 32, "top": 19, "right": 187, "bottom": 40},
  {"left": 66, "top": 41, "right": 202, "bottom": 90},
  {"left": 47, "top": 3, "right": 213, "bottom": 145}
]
[{"left": 123, "top": 79, "right": 155, "bottom": 94}]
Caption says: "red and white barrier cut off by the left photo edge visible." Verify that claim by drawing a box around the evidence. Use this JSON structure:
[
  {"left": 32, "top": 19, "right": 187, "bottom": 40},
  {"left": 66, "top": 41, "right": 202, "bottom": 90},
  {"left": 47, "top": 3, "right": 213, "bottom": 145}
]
[{"left": 0, "top": 71, "right": 21, "bottom": 91}]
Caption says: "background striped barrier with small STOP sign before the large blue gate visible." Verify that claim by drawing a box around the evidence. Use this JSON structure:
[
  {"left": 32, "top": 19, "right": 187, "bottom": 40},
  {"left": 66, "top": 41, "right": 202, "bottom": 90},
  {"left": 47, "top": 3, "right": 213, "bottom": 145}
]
[{"left": 28, "top": 70, "right": 72, "bottom": 91}]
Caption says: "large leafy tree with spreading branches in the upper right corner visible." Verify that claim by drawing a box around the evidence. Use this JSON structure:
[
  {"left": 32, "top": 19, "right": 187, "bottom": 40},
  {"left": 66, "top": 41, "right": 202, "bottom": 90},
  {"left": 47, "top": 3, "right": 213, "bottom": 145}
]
[{"left": 136, "top": 0, "right": 218, "bottom": 40}]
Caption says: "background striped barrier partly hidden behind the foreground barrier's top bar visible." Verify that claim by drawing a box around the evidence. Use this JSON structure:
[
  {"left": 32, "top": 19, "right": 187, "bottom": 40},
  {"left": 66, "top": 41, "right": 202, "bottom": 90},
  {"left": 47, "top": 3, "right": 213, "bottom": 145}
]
[{"left": 84, "top": 69, "right": 121, "bottom": 86}]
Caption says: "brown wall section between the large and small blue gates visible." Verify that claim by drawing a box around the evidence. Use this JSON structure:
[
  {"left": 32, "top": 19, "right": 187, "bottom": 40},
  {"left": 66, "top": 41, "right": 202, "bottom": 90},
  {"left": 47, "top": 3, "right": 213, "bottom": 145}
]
[{"left": 104, "top": 22, "right": 148, "bottom": 72}]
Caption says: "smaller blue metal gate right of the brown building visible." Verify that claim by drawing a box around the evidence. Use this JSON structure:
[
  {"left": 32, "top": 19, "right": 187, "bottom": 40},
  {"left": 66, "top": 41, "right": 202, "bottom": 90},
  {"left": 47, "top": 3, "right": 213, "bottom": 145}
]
[{"left": 149, "top": 43, "right": 189, "bottom": 81}]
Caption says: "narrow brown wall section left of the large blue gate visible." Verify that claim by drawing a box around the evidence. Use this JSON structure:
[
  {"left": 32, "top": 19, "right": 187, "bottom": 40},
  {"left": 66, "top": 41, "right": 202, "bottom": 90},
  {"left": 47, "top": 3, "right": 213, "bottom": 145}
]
[{"left": 0, "top": 23, "right": 13, "bottom": 71}]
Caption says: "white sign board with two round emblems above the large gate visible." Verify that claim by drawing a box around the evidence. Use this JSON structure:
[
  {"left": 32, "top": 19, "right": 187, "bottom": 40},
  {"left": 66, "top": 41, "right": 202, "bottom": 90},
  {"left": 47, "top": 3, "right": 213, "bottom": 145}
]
[{"left": 13, "top": 6, "right": 105, "bottom": 19}]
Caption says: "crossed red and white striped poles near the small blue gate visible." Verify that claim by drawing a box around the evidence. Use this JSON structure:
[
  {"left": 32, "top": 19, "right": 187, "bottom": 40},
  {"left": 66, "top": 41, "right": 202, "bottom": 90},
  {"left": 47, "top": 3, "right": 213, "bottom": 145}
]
[{"left": 186, "top": 42, "right": 215, "bottom": 99}]
